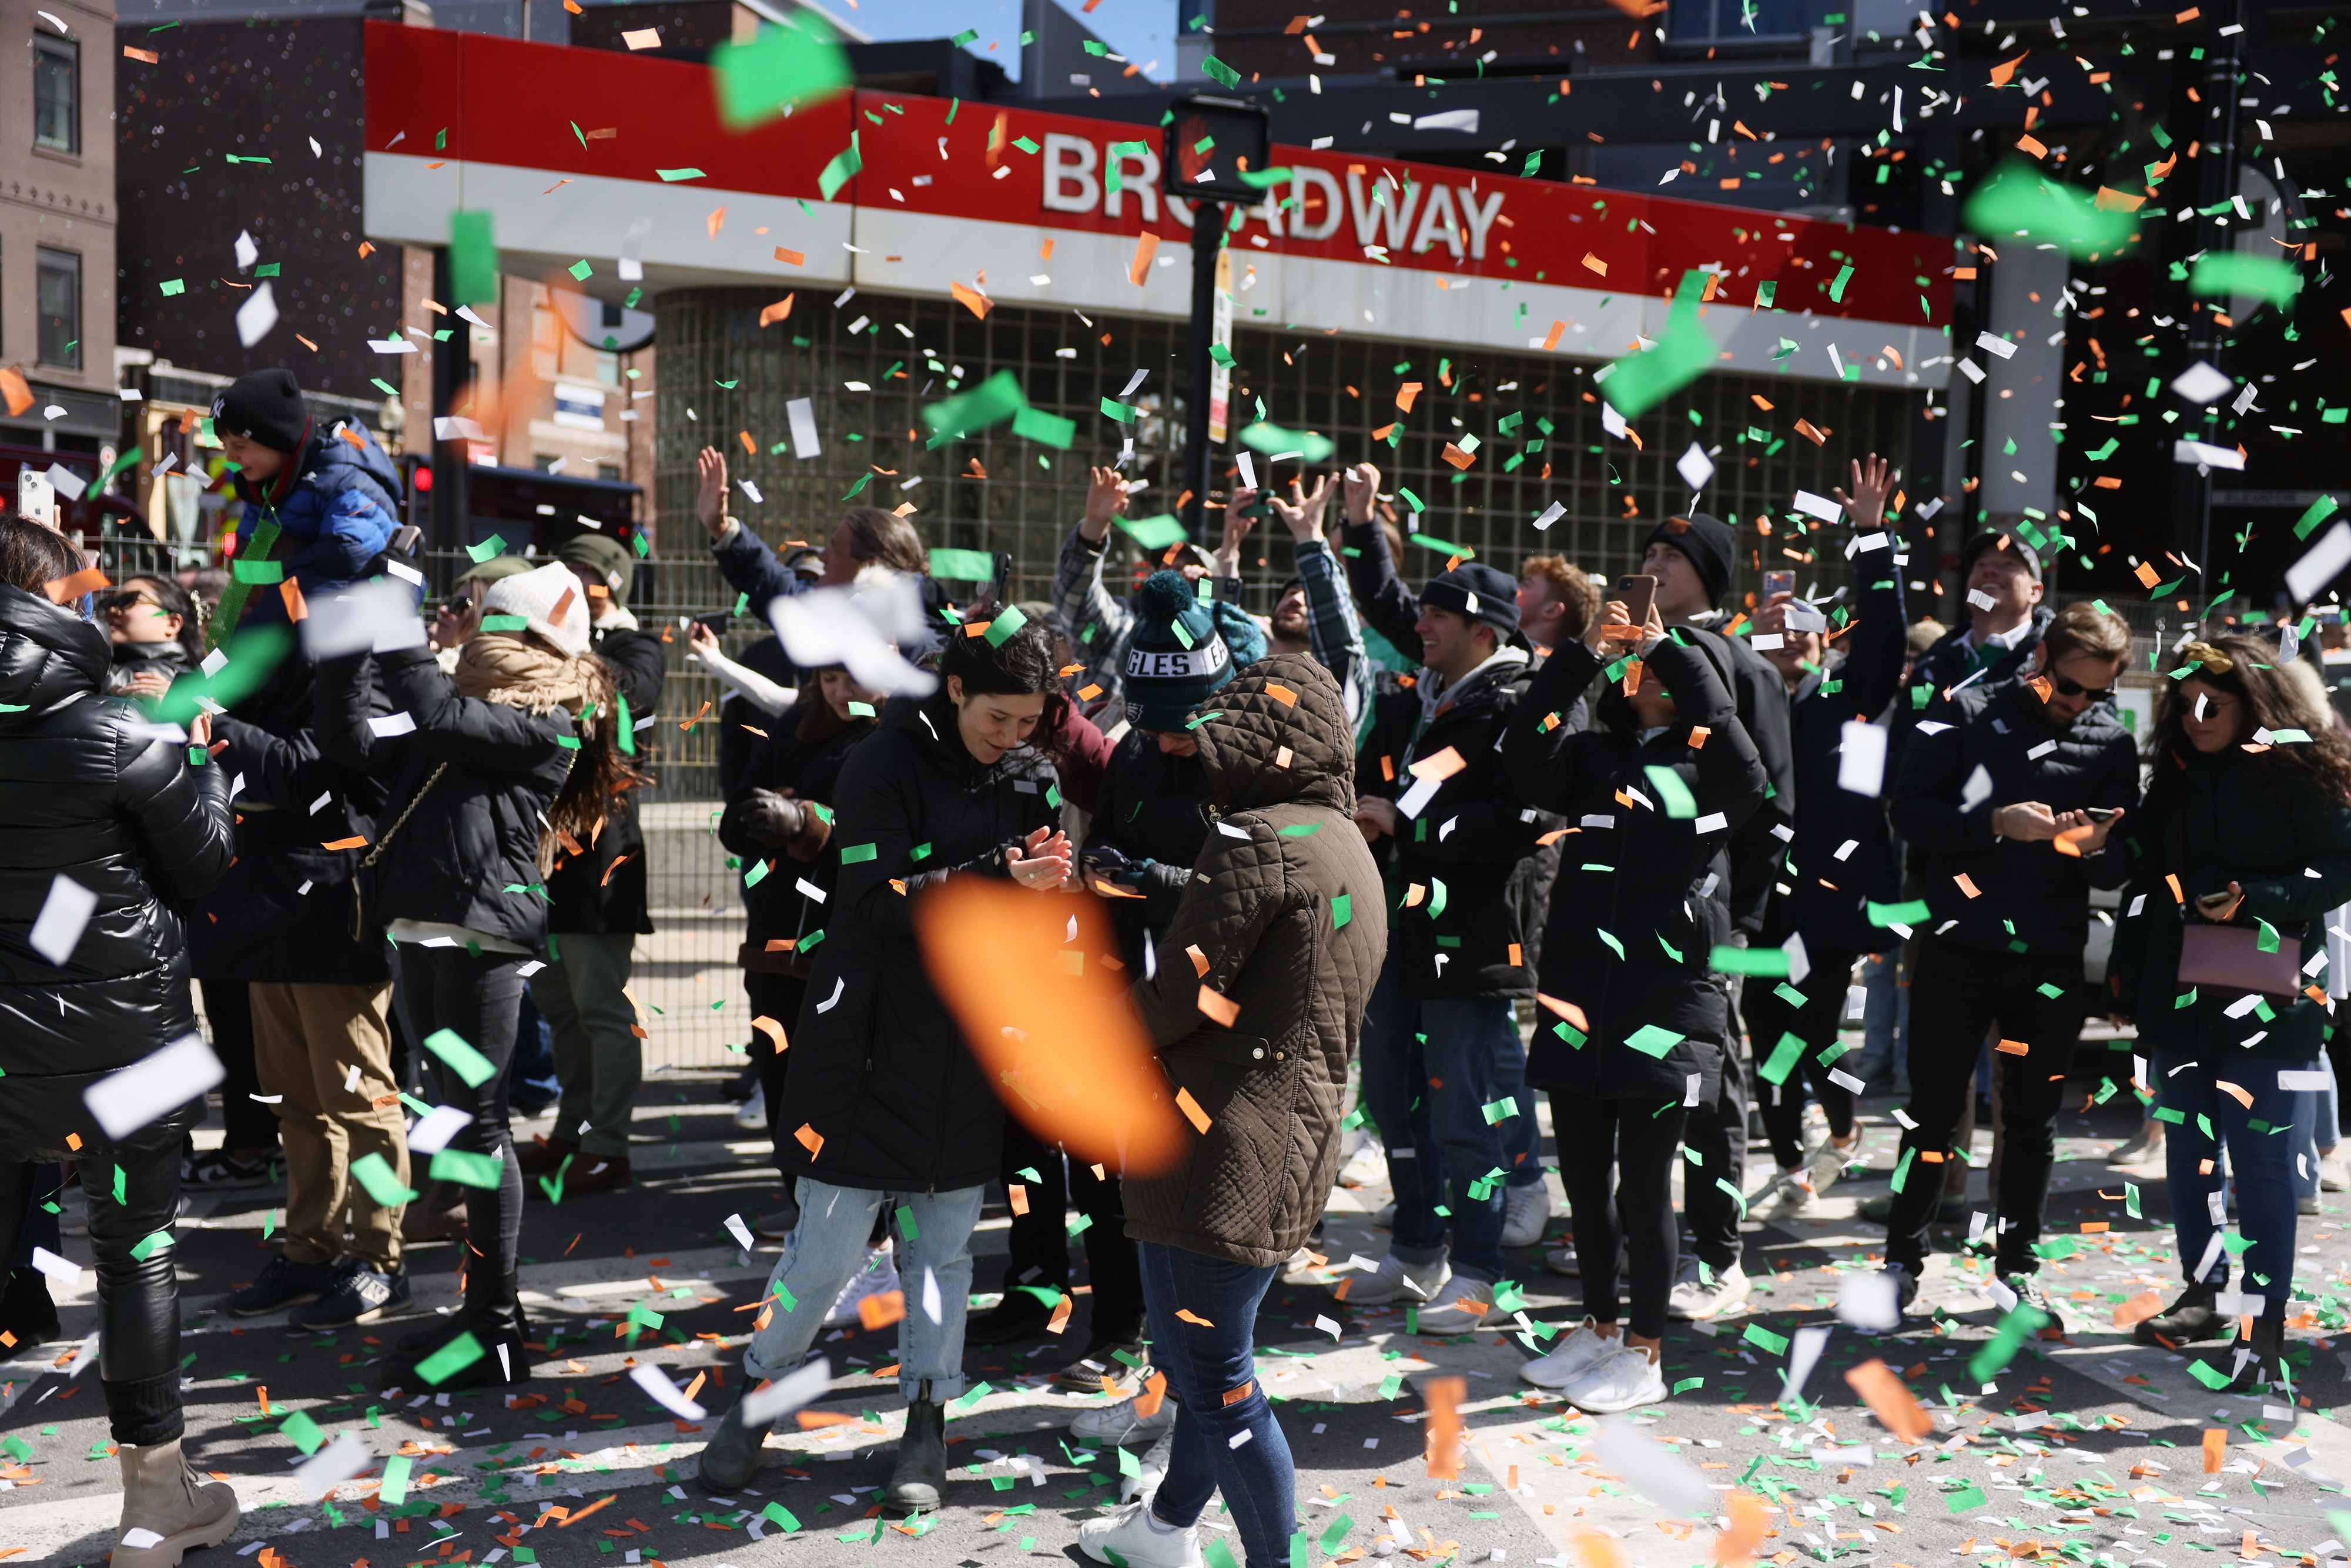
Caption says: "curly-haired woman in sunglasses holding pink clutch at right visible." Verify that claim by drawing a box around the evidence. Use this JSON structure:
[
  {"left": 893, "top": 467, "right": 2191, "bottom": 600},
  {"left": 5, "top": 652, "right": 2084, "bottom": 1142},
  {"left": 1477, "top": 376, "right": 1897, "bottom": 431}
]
[{"left": 2109, "top": 632, "right": 2351, "bottom": 1392}]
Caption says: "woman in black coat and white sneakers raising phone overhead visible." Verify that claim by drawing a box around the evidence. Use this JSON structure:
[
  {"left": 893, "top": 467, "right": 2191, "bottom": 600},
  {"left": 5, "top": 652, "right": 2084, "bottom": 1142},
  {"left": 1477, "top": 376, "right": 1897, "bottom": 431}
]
[{"left": 1502, "top": 604, "right": 1766, "bottom": 1413}]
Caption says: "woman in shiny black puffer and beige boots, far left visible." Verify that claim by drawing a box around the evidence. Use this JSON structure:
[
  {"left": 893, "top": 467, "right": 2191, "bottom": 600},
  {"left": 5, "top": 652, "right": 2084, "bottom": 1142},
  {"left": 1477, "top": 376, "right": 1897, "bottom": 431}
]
[{"left": 0, "top": 517, "right": 237, "bottom": 1568}]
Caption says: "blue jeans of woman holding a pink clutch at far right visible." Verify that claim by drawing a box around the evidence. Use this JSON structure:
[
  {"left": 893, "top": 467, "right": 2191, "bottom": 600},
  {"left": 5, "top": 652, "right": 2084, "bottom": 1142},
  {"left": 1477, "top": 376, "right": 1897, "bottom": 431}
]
[{"left": 2149, "top": 1051, "right": 2309, "bottom": 1319}]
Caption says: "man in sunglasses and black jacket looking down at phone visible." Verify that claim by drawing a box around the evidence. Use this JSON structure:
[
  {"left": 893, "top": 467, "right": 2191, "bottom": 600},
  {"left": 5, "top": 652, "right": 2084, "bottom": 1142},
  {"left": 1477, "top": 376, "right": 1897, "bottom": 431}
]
[{"left": 1886, "top": 604, "right": 2139, "bottom": 1331}]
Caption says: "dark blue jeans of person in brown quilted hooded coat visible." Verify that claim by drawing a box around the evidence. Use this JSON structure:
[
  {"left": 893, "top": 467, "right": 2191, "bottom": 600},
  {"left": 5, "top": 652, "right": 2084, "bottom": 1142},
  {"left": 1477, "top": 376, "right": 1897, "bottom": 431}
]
[{"left": 1136, "top": 1241, "right": 1298, "bottom": 1568}]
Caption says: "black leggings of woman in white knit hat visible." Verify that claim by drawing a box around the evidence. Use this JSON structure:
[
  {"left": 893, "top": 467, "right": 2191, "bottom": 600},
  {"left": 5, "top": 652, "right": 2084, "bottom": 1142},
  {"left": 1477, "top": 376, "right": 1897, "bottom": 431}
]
[{"left": 400, "top": 945, "right": 527, "bottom": 1342}]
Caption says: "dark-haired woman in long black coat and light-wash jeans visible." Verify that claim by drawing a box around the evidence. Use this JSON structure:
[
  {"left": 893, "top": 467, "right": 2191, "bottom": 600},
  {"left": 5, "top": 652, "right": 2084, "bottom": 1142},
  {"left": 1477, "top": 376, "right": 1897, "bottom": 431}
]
[{"left": 701, "top": 609, "right": 1084, "bottom": 1512}]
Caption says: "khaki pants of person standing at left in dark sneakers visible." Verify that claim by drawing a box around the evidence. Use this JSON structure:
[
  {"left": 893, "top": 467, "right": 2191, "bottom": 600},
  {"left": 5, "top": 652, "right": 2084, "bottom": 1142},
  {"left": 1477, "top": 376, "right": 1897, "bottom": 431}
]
[{"left": 252, "top": 980, "right": 409, "bottom": 1272}]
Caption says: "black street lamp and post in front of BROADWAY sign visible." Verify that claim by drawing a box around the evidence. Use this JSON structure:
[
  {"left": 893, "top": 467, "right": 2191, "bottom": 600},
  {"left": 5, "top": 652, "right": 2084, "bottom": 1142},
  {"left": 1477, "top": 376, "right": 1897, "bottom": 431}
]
[{"left": 1159, "top": 96, "right": 1274, "bottom": 538}]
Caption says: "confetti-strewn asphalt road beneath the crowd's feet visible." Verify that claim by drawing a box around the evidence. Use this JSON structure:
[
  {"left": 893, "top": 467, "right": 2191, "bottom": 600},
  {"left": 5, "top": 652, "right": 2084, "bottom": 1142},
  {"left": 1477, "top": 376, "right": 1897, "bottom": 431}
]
[{"left": 0, "top": 1074, "right": 2351, "bottom": 1568}]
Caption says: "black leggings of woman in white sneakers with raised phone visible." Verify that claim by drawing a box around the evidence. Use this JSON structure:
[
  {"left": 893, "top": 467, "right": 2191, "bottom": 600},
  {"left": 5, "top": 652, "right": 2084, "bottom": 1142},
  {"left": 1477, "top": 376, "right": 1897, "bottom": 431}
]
[{"left": 1552, "top": 1088, "right": 1688, "bottom": 1340}]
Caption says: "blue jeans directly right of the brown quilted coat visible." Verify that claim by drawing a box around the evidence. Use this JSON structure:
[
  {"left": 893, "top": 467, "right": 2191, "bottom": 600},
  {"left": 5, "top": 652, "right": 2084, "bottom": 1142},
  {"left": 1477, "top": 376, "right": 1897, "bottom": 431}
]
[{"left": 1361, "top": 957, "right": 1535, "bottom": 1281}]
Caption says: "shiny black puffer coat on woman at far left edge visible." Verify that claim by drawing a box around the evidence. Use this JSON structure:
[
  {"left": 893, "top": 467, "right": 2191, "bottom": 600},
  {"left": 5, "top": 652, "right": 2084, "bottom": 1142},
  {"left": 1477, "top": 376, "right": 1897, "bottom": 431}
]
[{"left": 0, "top": 585, "right": 233, "bottom": 1159}]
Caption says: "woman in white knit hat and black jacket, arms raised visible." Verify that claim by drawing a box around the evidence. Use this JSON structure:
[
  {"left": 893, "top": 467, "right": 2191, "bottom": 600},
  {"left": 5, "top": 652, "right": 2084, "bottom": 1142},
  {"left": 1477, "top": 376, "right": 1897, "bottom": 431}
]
[{"left": 317, "top": 562, "right": 642, "bottom": 1389}]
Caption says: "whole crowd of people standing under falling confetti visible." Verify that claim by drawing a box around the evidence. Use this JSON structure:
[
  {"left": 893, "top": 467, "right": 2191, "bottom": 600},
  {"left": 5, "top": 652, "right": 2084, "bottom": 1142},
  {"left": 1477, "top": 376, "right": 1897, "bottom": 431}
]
[{"left": 0, "top": 371, "right": 2351, "bottom": 1568}]
